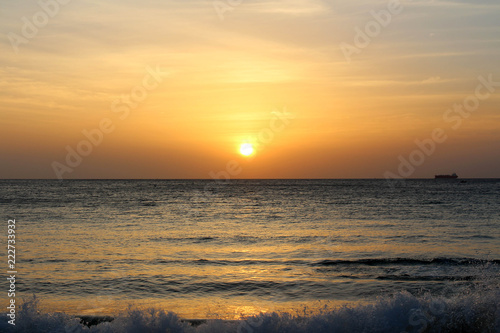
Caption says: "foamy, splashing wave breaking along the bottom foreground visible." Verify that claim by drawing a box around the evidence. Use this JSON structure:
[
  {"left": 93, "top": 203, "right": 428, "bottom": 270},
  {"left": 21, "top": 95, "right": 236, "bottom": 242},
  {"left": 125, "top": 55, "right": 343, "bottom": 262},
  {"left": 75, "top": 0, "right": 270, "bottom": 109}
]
[{"left": 0, "top": 289, "right": 500, "bottom": 333}]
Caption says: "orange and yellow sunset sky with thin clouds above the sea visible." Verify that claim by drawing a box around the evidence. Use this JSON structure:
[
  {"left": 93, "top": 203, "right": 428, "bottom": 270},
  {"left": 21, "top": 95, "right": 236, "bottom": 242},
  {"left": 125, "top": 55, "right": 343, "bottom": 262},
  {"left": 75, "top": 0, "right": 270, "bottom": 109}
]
[{"left": 0, "top": 0, "right": 500, "bottom": 179}]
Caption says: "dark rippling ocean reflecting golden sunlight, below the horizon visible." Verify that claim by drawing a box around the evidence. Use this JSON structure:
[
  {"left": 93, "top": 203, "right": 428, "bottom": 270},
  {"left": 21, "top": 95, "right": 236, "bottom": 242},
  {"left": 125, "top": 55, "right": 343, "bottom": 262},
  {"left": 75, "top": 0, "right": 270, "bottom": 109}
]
[{"left": 0, "top": 179, "right": 500, "bottom": 333}]
